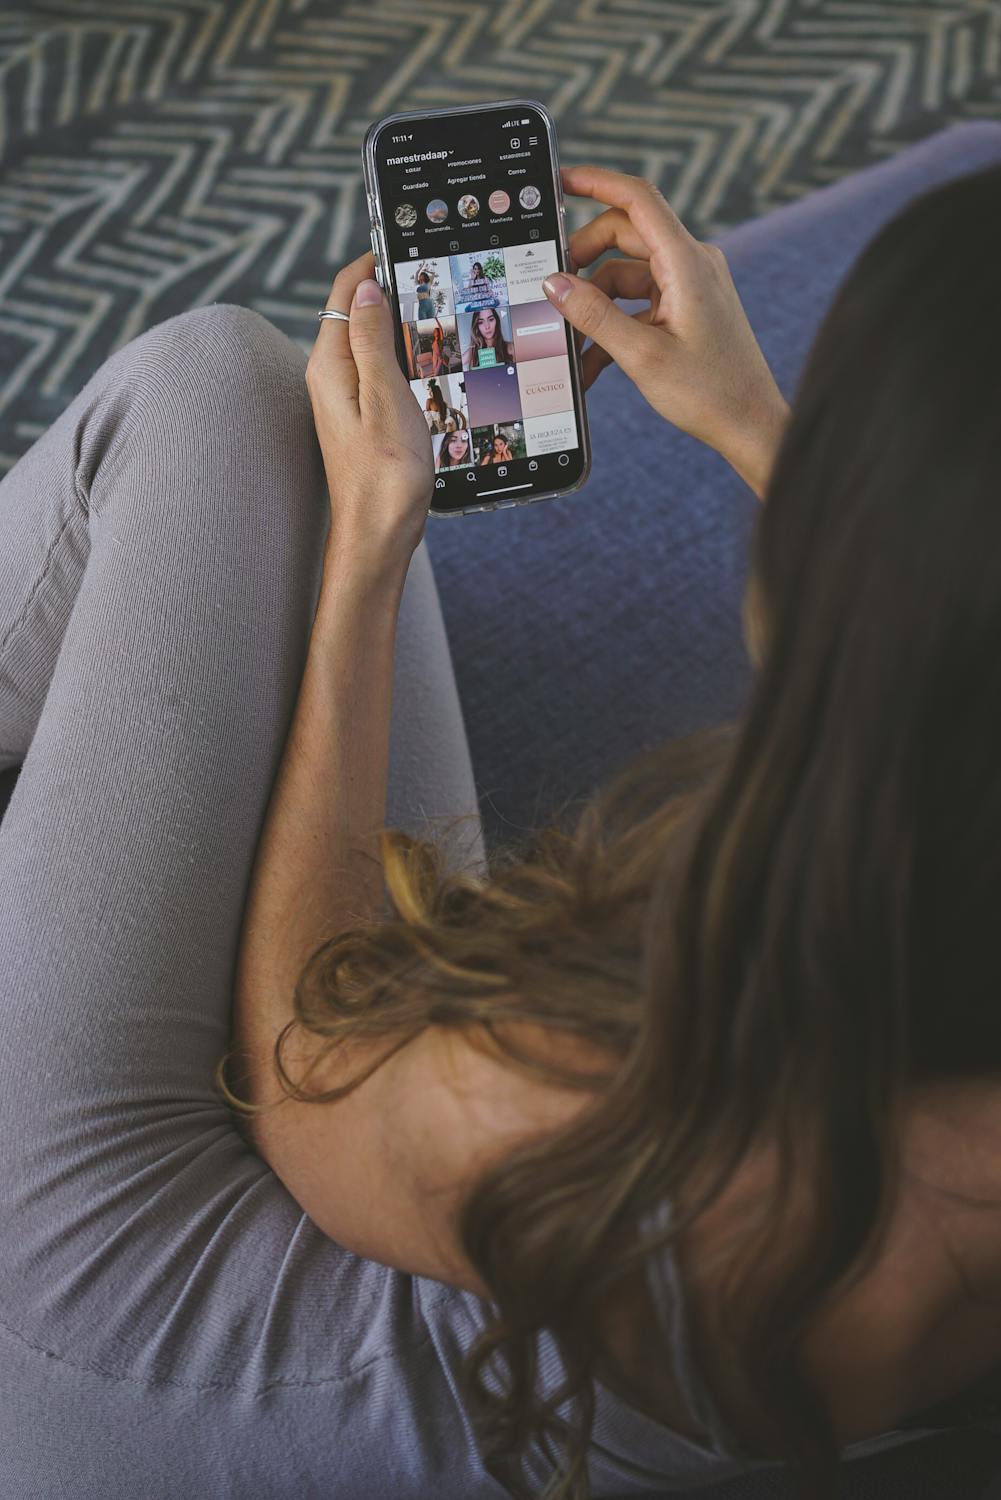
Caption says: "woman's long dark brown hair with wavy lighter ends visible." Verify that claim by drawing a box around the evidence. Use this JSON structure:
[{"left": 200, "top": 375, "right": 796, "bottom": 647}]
[{"left": 218, "top": 158, "right": 1001, "bottom": 1500}]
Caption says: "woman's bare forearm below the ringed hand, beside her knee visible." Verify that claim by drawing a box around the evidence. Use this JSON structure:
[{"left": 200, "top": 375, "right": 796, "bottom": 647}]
[{"left": 233, "top": 552, "right": 407, "bottom": 1103}]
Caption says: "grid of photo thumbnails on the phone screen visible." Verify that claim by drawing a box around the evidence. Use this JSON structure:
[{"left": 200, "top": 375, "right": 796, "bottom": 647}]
[{"left": 395, "top": 240, "right": 578, "bottom": 473}]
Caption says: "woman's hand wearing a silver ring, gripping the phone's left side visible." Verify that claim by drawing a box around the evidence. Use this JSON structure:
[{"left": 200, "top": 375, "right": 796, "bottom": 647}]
[{"left": 306, "top": 251, "right": 434, "bottom": 575}]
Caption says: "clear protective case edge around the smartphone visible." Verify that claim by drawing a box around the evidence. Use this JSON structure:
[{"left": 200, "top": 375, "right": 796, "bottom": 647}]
[{"left": 362, "top": 99, "right": 591, "bottom": 516}]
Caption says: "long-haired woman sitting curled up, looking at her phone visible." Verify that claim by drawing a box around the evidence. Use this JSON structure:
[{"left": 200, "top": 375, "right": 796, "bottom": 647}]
[{"left": 0, "top": 152, "right": 1001, "bottom": 1500}]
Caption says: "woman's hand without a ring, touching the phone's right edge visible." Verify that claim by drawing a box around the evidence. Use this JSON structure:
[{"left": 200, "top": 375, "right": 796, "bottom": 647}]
[{"left": 542, "top": 165, "right": 789, "bottom": 497}]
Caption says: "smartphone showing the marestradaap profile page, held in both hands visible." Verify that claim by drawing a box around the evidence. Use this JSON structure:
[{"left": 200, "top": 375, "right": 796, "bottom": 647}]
[{"left": 362, "top": 99, "right": 591, "bottom": 516}]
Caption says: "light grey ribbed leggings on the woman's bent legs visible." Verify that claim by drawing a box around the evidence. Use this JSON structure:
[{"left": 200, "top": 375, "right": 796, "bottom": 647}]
[{"left": 0, "top": 305, "right": 498, "bottom": 1500}]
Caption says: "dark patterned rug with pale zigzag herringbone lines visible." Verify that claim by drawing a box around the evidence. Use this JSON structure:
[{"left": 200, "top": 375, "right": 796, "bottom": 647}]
[{"left": 0, "top": 0, "right": 1001, "bottom": 474}]
